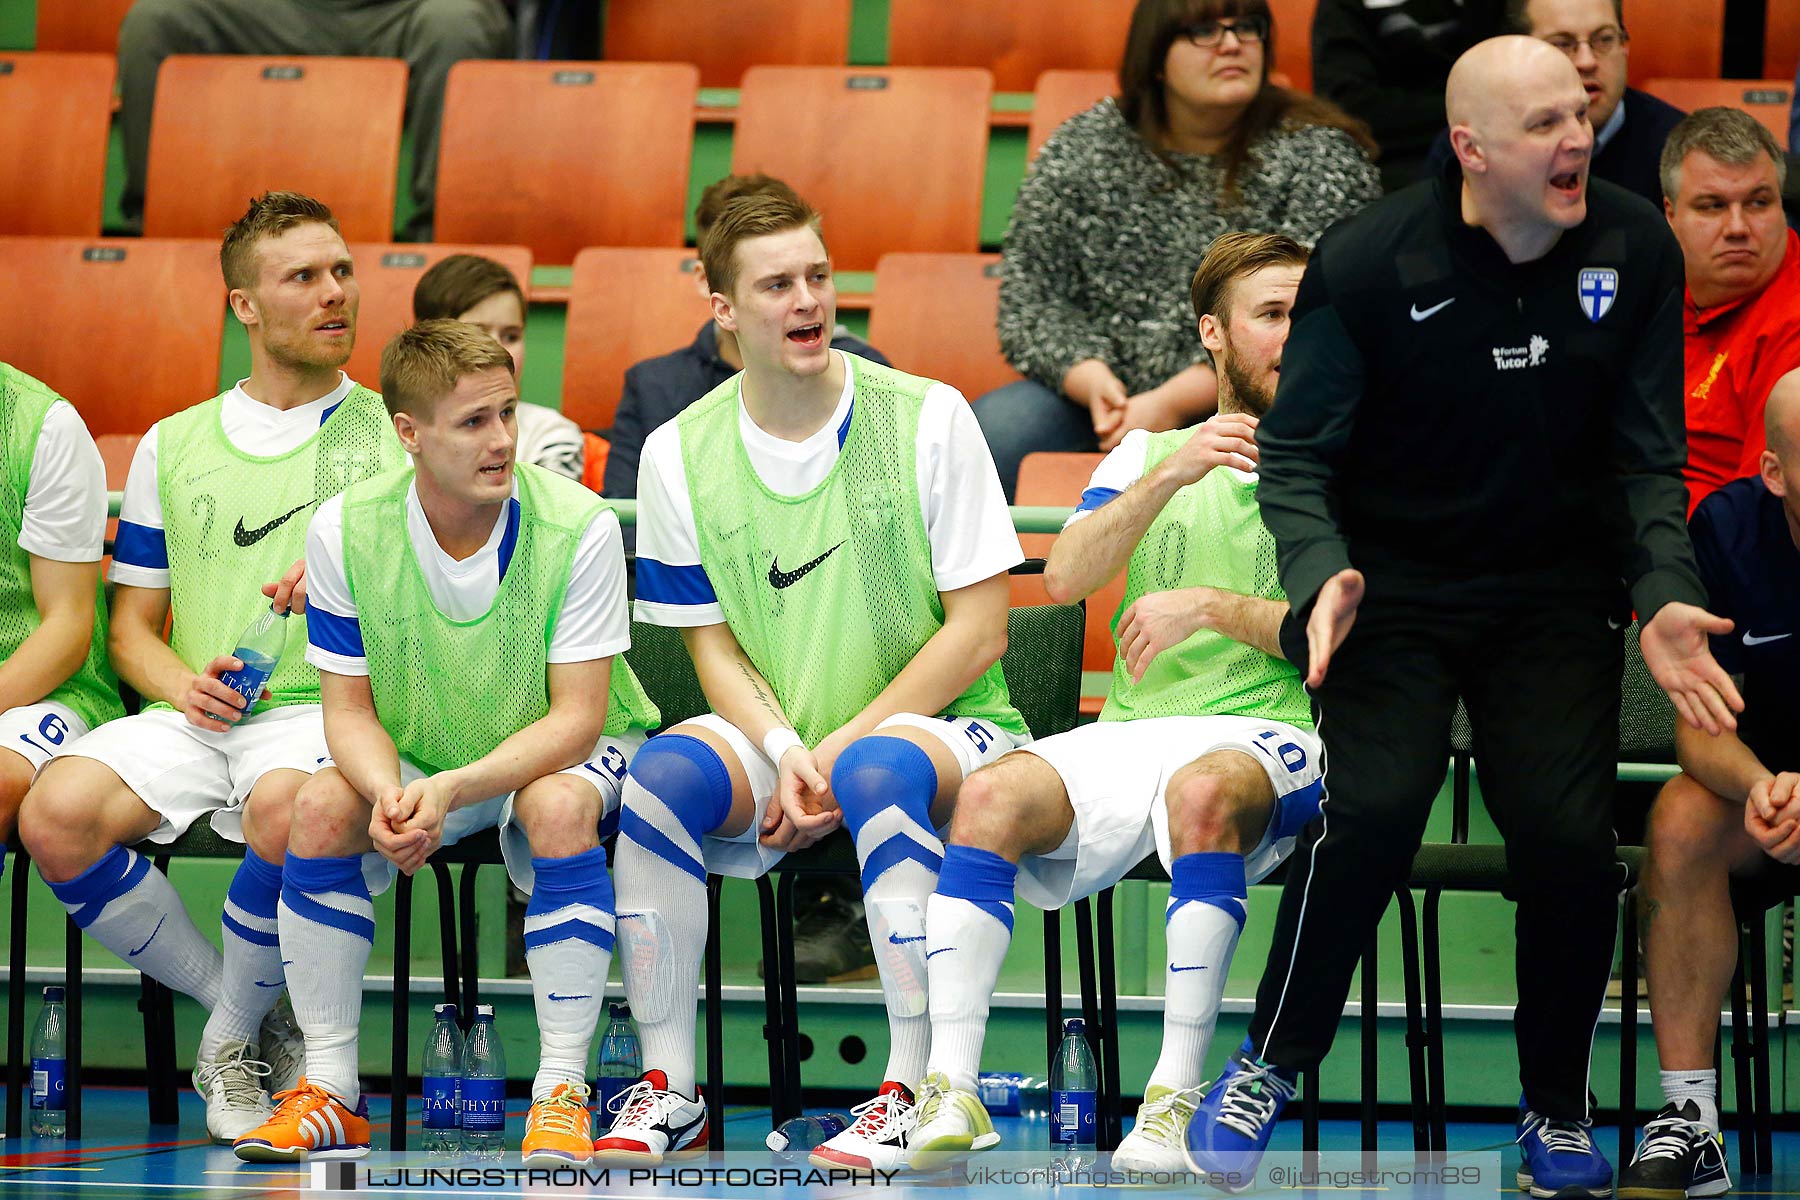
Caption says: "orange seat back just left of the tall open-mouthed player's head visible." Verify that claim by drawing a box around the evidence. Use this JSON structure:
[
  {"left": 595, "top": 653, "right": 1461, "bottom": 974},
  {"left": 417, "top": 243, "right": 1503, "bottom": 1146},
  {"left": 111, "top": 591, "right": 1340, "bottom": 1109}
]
[{"left": 563, "top": 246, "right": 709, "bottom": 430}]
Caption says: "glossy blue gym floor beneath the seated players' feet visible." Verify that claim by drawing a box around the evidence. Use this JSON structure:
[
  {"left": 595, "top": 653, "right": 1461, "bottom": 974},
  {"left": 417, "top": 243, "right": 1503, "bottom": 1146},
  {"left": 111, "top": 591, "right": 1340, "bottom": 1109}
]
[{"left": 0, "top": 1087, "right": 1800, "bottom": 1200}]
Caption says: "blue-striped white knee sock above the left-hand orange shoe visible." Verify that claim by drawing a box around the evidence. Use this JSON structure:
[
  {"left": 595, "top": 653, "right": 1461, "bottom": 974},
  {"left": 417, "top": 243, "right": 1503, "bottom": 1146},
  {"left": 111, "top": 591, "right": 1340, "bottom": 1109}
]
[{"left": 277, "top": 851, "right": 374, "bottom": 1108}]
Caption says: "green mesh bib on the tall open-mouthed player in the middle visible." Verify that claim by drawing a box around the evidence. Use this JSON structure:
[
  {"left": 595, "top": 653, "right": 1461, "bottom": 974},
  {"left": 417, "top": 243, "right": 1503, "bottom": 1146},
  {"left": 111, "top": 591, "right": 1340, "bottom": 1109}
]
[{"left": 677, "top": 354, "right": 1026, "bottom": 747}]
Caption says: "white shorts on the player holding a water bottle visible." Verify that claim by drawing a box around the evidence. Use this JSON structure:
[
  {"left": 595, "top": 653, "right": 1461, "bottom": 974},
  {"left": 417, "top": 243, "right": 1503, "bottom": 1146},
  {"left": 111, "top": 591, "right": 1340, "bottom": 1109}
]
[{"left": 65, "top": 703, "right": 331, "bottom": 844}]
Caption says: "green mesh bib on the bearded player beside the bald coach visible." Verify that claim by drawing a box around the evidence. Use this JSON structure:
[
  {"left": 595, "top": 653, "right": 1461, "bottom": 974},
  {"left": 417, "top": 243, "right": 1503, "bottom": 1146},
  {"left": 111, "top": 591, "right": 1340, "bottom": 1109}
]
[{"left": 1100, "top": 428, "right": 1312, "bottom": 729}]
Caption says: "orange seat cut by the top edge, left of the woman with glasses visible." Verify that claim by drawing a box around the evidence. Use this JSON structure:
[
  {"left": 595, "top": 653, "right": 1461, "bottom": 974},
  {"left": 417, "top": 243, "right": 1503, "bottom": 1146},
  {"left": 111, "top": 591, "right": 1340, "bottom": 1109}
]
[{"left": 887, "top": 0, "right": 1132, "bottom": 92}]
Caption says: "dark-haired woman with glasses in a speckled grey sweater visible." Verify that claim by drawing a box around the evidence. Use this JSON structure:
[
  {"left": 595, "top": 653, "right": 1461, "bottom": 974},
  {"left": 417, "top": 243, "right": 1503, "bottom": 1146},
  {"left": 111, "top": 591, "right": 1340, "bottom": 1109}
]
[{"left": 976, "top": 0, "right": 1381, "bottom": 498}]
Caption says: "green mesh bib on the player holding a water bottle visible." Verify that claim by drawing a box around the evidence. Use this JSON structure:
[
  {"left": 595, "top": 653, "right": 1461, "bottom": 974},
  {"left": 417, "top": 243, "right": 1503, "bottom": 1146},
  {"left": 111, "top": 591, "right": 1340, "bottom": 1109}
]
[{"left": 157, "top": 387, "right": 407, "bottom": 712}]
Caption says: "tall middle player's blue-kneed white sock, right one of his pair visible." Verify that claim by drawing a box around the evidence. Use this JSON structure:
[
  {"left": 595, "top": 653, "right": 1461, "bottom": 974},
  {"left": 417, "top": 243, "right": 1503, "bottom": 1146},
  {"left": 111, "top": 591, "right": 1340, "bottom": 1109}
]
[{"left": 832, "top": 734, "right": 943, "bottom": 1088}]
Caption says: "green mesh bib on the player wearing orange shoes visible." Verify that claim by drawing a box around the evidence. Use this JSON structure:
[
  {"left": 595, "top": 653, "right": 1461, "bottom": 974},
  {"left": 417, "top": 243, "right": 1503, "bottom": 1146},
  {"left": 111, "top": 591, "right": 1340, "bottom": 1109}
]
[{"left": 344, "top": 462, "right": 659, "bottom": 774}]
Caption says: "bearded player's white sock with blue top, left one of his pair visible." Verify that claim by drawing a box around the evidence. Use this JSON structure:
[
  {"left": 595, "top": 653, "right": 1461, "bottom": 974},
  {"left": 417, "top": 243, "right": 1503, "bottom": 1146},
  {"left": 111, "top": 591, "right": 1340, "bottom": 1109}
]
[{"left": 925, "top": 846, "right": 1019, "bottom": 1092}]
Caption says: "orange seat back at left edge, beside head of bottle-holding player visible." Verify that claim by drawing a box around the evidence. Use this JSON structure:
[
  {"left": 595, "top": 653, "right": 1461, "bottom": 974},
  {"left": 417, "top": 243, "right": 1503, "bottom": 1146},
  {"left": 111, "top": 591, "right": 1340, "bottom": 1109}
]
[{"left": 0, "top": 237, "right": 225, "bottom": 437}]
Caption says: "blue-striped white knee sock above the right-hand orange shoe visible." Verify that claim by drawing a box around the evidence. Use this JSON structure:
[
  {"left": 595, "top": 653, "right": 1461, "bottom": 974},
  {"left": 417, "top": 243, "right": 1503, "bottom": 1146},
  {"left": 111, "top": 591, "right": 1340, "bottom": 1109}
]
[{"left": 526, "top": 847, "right": 612, "bottom": 1103}]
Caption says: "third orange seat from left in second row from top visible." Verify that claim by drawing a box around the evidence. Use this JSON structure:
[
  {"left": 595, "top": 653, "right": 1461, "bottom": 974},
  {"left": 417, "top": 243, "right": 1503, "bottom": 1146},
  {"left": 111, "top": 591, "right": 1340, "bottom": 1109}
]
[{"left": 436, "top": 61, "right": 700, "bottom": 264}]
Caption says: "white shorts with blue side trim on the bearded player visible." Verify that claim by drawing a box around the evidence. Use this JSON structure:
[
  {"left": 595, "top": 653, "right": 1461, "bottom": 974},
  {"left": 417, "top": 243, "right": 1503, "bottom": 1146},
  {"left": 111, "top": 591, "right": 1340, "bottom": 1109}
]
[{"left": 1019, "top": 716, "right": 1323, "bottom": 909}]
